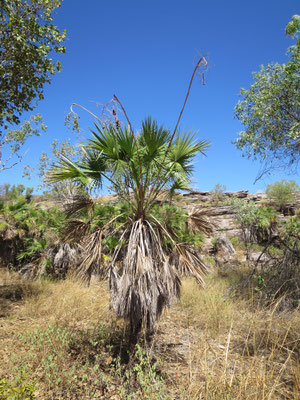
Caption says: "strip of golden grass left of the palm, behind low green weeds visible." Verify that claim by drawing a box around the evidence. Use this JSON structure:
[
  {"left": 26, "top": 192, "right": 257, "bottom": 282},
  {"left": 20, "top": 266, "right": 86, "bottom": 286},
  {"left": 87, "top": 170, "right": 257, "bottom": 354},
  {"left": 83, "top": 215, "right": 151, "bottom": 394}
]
[{"left": 0, "top": 270, "right": 110, "bottom": 326}]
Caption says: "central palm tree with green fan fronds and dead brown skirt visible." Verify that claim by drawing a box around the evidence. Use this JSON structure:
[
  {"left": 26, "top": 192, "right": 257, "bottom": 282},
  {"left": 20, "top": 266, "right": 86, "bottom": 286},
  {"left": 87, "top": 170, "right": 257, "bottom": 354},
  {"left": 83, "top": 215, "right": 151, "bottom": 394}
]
[{"left": 49, "top": 56, "right": 209, "bottom": 343}]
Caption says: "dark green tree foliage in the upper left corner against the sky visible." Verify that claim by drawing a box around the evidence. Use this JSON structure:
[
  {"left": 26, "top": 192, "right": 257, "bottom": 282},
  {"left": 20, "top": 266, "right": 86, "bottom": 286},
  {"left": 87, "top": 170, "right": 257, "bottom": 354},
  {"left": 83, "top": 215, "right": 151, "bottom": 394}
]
[{"left": 0, "top": 0, "right": 66, "bottom": 129}]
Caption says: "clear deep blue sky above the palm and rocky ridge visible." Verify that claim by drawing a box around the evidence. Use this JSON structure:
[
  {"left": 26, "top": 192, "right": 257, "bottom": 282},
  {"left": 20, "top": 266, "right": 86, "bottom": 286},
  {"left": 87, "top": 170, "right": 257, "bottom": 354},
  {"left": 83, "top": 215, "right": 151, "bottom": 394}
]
[{"left": 1, "top": 0, "right": 300, "bottom": 192}]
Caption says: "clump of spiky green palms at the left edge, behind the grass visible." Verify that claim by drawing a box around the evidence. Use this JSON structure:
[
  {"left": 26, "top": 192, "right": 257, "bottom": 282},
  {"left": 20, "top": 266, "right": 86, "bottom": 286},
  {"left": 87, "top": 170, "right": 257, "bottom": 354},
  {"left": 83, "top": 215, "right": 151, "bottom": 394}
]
[{"left": 0, "top": 198, "right": 64, "bottom": 278}]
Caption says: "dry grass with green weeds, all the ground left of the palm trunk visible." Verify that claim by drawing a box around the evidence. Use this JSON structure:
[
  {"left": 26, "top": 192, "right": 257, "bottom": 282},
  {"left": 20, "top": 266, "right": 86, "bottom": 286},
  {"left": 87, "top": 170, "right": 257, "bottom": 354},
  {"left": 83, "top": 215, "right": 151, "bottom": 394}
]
[{"left": 0, "top": 276, "right": 124, "bottom": 400}]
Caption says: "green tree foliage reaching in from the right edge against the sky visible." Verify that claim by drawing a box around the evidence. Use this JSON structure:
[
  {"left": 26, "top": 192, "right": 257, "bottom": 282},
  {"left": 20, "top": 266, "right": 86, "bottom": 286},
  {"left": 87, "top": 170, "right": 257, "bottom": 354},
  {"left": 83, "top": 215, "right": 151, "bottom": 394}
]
[{"left": 235, "top": 15, "right": 300, "bottom": 176}]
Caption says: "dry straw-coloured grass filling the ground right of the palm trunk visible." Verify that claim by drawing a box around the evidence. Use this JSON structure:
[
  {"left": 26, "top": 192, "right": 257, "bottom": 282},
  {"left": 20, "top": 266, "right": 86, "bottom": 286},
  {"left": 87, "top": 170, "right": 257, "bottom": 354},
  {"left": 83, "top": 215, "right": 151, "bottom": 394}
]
[{"left": 157, "top": 277, "right": 300, "bottom": 400}]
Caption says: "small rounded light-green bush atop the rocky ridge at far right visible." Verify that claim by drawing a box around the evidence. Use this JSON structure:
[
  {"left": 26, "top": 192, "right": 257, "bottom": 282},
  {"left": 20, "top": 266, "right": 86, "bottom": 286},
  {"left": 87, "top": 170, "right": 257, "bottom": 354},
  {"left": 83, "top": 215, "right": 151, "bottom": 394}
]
[{"left": 266, "top": 179, "right": 300, "bottom": 209}]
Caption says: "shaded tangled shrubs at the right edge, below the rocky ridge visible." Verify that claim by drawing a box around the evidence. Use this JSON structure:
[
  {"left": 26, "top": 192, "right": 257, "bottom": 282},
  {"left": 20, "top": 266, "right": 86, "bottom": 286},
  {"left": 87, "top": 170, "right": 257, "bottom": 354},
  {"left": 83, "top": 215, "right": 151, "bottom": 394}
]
[{"left": 227, "top": 199, "right": 300, "bottom": 310}]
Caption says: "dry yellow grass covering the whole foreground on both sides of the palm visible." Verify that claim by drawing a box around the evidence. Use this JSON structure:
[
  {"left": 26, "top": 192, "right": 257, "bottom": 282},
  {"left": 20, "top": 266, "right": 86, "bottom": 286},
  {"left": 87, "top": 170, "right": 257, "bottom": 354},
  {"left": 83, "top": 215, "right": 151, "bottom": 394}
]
[{"left": 0, "top": 275, "right": 300, "bottom": 400}]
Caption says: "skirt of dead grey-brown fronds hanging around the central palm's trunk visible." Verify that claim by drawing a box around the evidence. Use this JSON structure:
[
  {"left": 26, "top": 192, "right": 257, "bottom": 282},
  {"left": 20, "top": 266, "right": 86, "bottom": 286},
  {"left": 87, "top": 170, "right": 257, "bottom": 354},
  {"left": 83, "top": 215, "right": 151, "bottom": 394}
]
[{"left": 109, "top": 219, "right": 180, "bottom": 339}]
